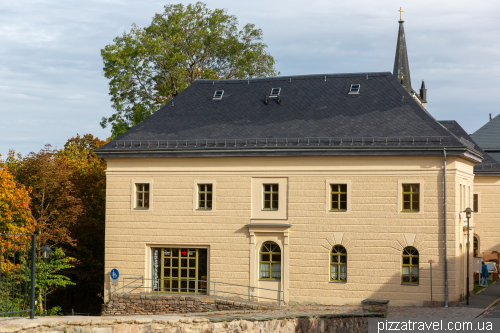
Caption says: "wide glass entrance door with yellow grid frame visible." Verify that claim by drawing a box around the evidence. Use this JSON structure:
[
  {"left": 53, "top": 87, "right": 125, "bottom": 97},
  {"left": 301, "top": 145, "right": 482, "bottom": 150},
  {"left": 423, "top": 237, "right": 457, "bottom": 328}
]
[{"left": 153, "top": 248, "right": 207, "bottom": 294}]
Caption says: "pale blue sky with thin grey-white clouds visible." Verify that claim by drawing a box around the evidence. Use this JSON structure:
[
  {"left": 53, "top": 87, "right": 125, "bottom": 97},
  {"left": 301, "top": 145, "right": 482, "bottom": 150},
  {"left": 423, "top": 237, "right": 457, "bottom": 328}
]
[{"left": 0, "top": 0, "right": 500, "bottom": 157}]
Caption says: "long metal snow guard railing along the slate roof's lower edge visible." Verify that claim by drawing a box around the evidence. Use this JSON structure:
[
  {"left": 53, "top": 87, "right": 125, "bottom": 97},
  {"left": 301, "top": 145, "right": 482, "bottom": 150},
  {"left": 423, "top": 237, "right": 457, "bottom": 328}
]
[{"left": 107, "top": 136, "right": 451, "bottom": 149}]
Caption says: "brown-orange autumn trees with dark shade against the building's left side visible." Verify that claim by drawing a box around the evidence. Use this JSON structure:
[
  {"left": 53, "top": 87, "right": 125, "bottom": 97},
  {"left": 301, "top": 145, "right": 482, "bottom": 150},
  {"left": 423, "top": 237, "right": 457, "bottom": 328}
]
[{"left": 0, "top": 134, "right": 107, "bottom": 313}]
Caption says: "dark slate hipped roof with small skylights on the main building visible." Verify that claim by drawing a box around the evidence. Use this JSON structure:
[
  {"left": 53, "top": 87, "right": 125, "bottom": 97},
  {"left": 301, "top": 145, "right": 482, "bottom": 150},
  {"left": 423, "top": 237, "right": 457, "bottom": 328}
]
[{"left": 96, "top": 72, "right": 472, "bottom": 157}]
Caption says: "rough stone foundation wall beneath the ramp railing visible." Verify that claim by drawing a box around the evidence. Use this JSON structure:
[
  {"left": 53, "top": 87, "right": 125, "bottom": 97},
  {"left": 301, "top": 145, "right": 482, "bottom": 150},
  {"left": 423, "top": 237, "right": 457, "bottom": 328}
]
[{"left": 101, "top": 294, "right": 274, "bottom": 316}]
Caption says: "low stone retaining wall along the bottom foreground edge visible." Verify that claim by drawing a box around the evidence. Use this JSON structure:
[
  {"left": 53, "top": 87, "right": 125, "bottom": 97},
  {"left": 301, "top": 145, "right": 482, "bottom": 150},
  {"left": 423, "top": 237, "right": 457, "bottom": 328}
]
[{"left": 0, "top": 314, "right": 381, "bottom": 333}]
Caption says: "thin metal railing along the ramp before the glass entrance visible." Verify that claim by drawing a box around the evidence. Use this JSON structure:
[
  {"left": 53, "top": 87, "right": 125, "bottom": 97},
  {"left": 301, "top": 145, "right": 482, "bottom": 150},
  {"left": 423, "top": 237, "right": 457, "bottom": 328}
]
[{"left": 122, "top": 276, "right": 285, "bottom": 308}]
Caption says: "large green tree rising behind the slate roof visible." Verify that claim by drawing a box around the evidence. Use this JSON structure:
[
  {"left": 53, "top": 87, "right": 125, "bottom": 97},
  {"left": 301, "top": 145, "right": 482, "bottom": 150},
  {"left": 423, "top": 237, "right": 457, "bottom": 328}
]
[{"left": 101, "top": 2, "right": 279, "bottom": 138}]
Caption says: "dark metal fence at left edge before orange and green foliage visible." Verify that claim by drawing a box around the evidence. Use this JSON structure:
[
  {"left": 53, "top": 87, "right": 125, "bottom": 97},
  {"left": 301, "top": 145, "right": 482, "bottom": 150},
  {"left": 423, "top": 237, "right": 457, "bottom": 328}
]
[{"left": 0, "top": 234, "right": 36, "bottom": 319}]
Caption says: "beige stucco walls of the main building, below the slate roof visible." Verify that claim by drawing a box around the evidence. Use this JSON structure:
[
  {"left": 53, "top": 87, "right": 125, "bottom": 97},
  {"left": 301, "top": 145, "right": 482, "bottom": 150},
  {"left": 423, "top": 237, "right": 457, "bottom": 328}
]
[{"left": 98, "top": 152, "right": 480, "bottom": 305}]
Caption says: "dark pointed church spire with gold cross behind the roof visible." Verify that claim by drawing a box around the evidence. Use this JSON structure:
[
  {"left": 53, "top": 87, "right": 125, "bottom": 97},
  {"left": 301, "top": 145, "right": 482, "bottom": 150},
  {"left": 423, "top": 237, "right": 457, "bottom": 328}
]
[{"left": 392, "top": 7, "right": 427, "bottom": 108}]
